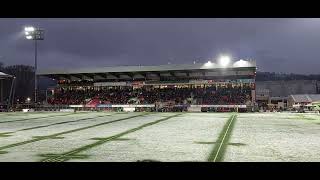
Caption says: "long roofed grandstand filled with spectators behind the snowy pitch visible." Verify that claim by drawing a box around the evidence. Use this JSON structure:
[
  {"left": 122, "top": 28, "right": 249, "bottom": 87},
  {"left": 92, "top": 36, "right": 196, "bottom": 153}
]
[{"left": 37, "top": 60, "right": 256, "bottom": 111}]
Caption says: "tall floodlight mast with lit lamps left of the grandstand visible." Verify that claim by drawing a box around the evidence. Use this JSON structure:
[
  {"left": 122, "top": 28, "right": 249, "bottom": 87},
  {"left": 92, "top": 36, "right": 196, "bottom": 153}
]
[{"left": 24, "top": 26, "right": 44, "bottom": 105}]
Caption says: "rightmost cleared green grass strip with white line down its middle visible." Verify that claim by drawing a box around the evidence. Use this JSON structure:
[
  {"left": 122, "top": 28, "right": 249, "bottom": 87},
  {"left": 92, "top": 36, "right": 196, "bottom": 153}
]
[{"left": 208, "top": 114, "right": 237, "bottom": 162}]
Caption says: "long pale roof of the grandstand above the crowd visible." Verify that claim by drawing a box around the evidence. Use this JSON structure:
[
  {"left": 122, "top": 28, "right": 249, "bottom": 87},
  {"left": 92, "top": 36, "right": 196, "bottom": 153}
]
[{"left": 37, "top": 60, "right": 256, "bottom": 80}]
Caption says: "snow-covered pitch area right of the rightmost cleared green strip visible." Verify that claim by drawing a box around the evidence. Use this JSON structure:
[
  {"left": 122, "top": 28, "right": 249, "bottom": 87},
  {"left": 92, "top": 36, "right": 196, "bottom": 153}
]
[{"left": 224, "top": 113, "right": 320, "bottom": 161}]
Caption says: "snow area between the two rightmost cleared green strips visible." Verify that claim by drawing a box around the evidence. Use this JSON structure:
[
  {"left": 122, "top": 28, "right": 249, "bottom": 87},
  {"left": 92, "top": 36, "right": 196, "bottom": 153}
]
[{"left": 72, "top": 113, "right": 230, "bottom": 161}]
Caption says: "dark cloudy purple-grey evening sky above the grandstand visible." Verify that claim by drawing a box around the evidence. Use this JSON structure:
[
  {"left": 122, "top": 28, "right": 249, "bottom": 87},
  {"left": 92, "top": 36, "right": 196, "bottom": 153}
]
[{"left": 0, "top": 18, "right": 320, "bottom": 74}]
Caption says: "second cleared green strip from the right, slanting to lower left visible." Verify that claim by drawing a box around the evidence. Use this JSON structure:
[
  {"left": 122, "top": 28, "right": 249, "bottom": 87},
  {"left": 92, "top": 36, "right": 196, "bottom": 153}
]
[{"left": 41, "top": 114, "right": 181, "bottom": 162}]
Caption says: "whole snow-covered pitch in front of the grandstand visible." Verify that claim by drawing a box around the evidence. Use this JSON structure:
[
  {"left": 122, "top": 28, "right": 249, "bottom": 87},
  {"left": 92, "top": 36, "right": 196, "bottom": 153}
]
[{"left": 0, "top": 112, "right": 320, "bottom": 162}]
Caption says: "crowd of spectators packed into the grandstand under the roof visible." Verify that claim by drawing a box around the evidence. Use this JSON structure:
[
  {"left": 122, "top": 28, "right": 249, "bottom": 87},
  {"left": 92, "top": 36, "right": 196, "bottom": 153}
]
[{"left": 48, "top": 86, "right": 251, "bottom": 105}]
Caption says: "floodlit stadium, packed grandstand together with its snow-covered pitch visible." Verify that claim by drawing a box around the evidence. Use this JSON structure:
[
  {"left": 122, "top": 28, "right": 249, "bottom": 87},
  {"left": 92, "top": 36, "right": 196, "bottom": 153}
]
[{"left": 0, "top": 57, "right": 320, "bottom": 162}]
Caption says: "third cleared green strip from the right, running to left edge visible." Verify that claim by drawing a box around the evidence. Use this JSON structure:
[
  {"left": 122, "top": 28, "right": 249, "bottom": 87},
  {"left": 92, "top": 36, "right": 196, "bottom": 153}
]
[{"left": 0, "top": 113, "right": 148, "bottom": 150}]
